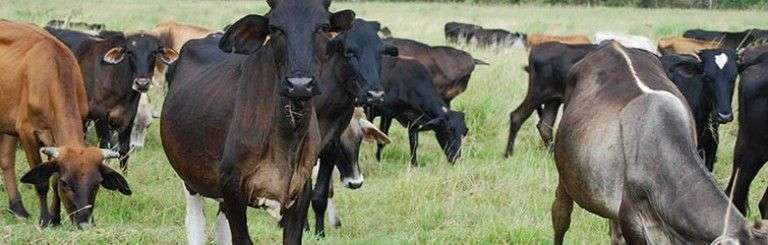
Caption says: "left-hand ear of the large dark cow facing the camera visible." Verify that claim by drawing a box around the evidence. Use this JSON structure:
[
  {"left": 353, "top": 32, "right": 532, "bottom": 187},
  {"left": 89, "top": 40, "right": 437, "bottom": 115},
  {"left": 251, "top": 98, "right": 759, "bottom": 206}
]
[{"left": 219, "top": 14, "right": 269, "bottom": 54}]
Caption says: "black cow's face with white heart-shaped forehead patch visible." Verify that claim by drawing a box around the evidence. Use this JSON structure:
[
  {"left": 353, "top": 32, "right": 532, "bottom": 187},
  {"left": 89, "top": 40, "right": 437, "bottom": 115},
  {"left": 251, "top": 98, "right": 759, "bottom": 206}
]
[{"left": 699, "top": 49, "right": 739, "bottom": 123}]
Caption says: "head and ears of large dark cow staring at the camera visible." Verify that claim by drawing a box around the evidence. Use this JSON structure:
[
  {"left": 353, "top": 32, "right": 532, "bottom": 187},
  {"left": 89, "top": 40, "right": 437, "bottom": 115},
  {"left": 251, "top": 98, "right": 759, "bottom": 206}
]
[{"left": 219, "top": 0, "right": 355, "bottom": 100}]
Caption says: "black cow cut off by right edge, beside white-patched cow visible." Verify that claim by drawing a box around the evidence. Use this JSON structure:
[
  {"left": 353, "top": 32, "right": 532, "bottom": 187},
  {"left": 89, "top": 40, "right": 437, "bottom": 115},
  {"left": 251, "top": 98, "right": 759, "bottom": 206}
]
[{"left": 726, "top": 46, "right": 768, "bottom": 219}]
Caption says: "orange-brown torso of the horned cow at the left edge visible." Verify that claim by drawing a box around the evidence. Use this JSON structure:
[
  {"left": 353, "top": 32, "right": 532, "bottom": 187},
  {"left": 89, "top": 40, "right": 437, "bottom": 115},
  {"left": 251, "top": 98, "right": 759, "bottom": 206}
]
[{"left": 0, "top": 21, "right": 88, "bottom": 136}]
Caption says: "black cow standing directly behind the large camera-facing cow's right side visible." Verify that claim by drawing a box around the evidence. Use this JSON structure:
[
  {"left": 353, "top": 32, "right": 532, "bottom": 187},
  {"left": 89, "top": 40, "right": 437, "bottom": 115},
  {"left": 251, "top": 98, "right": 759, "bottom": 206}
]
[{"left": 312, "top": 19, "right": 397, "bottom": 236}]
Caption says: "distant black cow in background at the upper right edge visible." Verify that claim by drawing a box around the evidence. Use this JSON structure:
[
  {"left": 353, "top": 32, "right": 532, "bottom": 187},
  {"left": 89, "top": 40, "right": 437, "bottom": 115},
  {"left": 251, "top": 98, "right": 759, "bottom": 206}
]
[{"left": 683, "top": 29, "right": 768, "bottom": 50}]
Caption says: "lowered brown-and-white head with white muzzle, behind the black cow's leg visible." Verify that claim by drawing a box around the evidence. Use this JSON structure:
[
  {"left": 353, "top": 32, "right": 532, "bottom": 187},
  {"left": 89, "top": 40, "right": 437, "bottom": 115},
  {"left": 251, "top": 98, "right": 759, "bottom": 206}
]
[{"left": 334, "top": 108, "right": 391, "bottom": 189}]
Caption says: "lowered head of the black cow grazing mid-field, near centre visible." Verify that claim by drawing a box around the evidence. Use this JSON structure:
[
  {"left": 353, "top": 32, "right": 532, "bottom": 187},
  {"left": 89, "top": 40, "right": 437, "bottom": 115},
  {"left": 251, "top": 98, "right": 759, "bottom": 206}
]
[{"left": 420, "top": 107, "right": 469, "bottom": 163}]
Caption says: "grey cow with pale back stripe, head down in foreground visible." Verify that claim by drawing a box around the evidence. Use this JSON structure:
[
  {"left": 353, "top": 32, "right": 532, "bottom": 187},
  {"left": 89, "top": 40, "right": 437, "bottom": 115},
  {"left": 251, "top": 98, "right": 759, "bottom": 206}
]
[{"left": 552, "top": 42, "right": 768, "bottom": 244}]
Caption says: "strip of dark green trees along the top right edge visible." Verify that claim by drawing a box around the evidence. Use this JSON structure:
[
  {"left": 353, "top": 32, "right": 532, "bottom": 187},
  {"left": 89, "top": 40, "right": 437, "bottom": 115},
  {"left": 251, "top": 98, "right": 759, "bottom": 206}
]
[{"left": 344, "top": 0, "right": 768, "bottom": 9}]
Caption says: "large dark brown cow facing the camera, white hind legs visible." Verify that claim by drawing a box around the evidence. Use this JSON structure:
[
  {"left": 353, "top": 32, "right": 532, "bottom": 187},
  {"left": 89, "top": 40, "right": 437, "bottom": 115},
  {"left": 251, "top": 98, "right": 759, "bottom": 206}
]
[{"left": 161, "top": 0, "right": 354, "bottom": 244}]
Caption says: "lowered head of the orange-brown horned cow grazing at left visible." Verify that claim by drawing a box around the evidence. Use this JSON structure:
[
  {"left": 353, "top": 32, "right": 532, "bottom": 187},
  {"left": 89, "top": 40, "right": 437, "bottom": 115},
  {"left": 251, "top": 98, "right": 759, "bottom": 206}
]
[{"left": 21, "top": 147, "right": 131, "bottom": 229}]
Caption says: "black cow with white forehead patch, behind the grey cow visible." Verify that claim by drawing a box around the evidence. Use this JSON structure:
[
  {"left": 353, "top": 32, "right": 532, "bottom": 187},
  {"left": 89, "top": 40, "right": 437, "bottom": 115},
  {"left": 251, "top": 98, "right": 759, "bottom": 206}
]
[{"left": 661, "top": 49, "right": 738, "bottom": 171}]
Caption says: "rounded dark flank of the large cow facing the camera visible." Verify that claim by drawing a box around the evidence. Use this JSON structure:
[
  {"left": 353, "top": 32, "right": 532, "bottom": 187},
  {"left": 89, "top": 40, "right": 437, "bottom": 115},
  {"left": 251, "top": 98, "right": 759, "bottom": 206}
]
[{"left": 160, "top": 34, "right": 246, "bottom": 197}]
